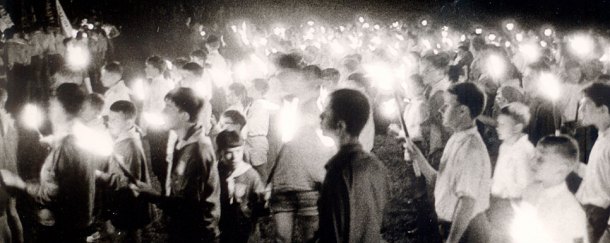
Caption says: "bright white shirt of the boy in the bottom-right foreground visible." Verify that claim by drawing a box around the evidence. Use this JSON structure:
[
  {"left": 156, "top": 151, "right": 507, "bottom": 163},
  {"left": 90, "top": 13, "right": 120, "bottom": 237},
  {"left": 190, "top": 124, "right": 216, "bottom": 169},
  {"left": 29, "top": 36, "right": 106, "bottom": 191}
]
[{"left": 523, "top": 182, "right": 589, "bottom": 243}]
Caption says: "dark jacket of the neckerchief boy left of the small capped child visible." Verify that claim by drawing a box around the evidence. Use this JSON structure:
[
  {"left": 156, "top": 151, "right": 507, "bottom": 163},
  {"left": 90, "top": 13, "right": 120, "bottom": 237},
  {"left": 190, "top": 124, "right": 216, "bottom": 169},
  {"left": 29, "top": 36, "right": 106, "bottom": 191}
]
[{"left": 159, "top": 126, "right": 220, "bottom": 242}]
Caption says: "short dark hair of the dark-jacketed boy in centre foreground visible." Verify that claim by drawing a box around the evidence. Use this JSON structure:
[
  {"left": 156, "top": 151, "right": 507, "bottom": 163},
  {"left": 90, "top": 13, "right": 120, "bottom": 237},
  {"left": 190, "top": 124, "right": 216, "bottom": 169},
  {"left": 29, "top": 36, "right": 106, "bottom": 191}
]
[{"left": 329, "top": 89, "right": 371, "bottom": 136}]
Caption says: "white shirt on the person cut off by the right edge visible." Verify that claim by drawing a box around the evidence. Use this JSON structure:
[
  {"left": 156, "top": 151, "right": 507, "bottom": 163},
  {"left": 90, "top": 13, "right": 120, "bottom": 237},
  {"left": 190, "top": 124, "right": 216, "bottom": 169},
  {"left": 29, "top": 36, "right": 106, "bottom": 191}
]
[{"left": 576, "top": 128, "right": 610, "bottom": 208}]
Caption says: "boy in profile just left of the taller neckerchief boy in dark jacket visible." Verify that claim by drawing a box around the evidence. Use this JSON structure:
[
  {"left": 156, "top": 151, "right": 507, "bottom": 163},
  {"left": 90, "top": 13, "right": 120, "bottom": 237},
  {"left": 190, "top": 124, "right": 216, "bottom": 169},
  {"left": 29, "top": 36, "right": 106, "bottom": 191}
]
[{"left": 96, "top": 100, "right": 151, "bottom": 242}]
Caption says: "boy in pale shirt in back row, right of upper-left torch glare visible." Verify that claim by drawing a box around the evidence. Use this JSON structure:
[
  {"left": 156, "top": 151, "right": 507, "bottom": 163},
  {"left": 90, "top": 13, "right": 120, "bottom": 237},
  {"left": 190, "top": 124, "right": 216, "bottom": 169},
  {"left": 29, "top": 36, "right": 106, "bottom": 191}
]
[{"left": 100, "top": 62, "right": 131, "bottom": 116}]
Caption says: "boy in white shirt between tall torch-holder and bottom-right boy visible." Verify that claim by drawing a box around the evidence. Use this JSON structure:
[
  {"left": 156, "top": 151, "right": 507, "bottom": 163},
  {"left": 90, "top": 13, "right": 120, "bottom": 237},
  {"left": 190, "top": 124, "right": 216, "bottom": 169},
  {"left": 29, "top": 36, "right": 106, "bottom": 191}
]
[{"left": 488, "top": 103, "right": 536, "bottom": 242}]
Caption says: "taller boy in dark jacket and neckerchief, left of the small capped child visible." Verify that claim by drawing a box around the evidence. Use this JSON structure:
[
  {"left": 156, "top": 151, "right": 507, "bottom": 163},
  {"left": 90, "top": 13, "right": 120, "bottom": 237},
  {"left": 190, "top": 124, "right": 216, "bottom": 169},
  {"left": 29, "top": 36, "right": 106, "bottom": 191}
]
[{"left": 134, "top": 88, "right": 220, "bottom": 242}]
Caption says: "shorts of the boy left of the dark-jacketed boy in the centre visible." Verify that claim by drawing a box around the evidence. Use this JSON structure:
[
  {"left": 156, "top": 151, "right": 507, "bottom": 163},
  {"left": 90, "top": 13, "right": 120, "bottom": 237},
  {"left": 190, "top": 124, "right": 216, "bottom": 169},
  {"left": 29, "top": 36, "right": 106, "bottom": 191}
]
[{"left": 269, "top": 191, "right": 320, "bottom": 216}]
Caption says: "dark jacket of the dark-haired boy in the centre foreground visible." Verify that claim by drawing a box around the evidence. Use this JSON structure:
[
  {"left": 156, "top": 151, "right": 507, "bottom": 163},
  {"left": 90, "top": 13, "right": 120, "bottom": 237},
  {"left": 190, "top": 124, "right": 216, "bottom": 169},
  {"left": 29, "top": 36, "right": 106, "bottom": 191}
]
[{"left": 318, "top": 144, "right": 388, "bottom": 243}]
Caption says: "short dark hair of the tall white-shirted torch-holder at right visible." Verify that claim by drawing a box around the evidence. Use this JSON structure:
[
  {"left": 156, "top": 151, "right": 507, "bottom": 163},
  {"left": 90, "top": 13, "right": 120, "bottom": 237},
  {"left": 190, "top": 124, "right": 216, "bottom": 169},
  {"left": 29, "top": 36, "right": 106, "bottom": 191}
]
[{"left": 447, "top": 83, "right": 485, "bottom": 119}]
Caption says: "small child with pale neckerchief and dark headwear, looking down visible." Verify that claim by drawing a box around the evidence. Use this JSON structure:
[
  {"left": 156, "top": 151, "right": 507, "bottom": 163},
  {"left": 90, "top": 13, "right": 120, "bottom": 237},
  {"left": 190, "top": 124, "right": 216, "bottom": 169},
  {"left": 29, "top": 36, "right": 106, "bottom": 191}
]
[{"left": 216, "top": 130, "right": 264, "bottom": 243}]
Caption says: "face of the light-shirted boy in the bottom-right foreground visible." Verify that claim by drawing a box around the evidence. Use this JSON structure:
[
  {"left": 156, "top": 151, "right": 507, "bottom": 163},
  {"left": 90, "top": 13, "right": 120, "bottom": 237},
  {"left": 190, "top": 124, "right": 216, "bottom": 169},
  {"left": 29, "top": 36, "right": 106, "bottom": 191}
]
[{"left": 533, "top": 146, "right": 568, "bottom": 184}]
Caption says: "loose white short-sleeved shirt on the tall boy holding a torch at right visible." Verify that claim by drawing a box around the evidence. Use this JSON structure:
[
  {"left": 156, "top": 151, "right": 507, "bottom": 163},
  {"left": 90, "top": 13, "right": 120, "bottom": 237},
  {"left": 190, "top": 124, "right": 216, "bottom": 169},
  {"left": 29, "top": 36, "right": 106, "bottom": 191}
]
[{"left": 434, "top": 126, "right": 491, "bottom": 222}]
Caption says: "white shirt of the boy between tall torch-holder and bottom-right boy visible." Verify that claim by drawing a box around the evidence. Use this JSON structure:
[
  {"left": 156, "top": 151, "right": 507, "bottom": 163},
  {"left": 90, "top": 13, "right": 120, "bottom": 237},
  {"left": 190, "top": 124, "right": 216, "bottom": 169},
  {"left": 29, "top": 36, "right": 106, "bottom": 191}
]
[{"left": 491, "top": 135, "right": 536, "bottom": 199}]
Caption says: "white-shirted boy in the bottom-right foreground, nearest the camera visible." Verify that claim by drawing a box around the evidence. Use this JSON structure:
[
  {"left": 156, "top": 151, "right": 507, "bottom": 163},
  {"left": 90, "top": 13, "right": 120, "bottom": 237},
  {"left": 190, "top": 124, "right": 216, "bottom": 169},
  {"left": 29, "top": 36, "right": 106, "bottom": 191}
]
[{"left": 515, "top": 136, "right": 589, "bottom": 243}]
